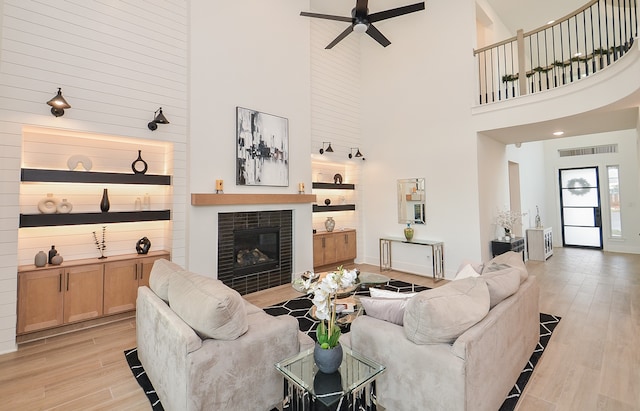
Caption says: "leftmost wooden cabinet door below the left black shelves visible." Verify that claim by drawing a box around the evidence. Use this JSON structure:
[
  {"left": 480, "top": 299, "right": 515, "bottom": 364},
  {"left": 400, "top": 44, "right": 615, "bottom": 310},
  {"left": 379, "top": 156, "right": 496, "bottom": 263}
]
[{"left": 17, "top": 268, "right": 64, "bottom": 334}]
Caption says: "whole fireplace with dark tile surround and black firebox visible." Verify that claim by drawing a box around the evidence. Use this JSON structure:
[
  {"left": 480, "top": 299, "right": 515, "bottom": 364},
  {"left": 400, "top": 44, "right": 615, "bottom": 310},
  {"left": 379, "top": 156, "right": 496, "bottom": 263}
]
[{"left": 218, "top": 210, "right": 293, "bottom": 295}]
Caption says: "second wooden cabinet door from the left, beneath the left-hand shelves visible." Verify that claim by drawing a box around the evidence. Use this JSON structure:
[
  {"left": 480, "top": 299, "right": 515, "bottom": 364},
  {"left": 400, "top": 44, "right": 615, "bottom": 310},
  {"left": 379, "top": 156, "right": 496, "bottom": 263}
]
[{"left": 64, "top": 264, "right": 103, "bottom": 323}]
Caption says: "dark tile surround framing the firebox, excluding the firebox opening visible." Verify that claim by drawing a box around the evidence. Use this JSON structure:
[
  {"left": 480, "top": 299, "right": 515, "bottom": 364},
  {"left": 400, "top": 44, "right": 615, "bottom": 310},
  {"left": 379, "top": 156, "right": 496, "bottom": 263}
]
[{"left": 218, "top": 210, "right": 293, "bottom": 295}]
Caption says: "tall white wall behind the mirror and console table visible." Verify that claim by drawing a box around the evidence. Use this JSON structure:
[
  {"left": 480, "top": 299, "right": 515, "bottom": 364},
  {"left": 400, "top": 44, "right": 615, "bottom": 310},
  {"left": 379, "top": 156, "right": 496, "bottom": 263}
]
[{"left": 361, "top": 0, "right": 481, "bottom": 277}]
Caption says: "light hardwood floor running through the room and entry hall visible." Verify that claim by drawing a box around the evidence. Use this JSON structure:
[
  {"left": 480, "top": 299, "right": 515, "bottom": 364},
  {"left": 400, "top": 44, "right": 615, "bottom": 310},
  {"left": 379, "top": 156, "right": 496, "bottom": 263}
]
[{"left": 0, "top": 249, "right": 640, "bottom": 411}]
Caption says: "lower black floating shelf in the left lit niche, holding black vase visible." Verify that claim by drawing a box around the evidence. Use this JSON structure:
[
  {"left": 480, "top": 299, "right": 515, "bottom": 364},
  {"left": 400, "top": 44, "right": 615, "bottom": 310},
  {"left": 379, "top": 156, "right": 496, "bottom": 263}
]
[{"left": 20, "top": 210, "right": 171, "bottom": 228}]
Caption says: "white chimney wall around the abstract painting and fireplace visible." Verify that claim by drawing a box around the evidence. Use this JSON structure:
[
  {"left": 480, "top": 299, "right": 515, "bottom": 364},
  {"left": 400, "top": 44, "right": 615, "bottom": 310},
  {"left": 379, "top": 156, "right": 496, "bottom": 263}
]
[{"left": 187, "top": 0, "right": 313, "bottom": 277}]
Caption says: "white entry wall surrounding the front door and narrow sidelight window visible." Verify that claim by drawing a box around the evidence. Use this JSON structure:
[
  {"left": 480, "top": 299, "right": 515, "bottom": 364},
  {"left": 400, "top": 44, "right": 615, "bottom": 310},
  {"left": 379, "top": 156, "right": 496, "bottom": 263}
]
[{"left": 543, "top": 130, "right": 640, "bottom": 254}]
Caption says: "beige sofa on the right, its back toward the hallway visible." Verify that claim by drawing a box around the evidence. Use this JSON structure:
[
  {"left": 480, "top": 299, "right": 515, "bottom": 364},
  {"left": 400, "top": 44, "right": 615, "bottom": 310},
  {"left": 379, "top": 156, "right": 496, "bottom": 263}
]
[{"left": 341, "top": 252, "right": 539, "bottom": 411}]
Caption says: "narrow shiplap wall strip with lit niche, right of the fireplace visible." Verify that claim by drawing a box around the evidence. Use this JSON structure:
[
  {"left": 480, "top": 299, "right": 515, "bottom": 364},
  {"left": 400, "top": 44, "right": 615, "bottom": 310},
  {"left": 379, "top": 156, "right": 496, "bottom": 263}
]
[{"left": 311, "top": 16, "right": 366, "bottom": 248}]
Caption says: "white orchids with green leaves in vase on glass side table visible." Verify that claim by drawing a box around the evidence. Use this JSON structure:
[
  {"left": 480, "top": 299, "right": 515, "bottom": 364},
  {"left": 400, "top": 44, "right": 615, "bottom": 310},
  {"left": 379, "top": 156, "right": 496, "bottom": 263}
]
[{"left": 297, "top": 266, "right": 358, "bottom": 349}]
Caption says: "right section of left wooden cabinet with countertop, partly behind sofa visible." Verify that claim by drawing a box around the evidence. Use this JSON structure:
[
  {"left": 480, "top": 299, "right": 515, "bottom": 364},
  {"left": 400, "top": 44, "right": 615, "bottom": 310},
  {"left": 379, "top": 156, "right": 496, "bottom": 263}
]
[{"left": 104, "top": 253, "right": 169, "bottom": 315}]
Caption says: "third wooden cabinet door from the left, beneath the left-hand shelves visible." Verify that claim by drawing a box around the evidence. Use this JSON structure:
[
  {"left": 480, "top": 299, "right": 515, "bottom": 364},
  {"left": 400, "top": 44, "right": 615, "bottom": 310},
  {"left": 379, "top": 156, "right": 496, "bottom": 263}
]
[{"left": 104, "top": 260, "right": 140, "bottom": 315}]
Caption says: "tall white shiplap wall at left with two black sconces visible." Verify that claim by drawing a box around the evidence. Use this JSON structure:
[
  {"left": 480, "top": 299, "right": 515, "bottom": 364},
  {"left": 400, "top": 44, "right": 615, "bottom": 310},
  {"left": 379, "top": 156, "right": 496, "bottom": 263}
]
[{"left": 0, "top": 0, "right": 189, "bottom": 353}]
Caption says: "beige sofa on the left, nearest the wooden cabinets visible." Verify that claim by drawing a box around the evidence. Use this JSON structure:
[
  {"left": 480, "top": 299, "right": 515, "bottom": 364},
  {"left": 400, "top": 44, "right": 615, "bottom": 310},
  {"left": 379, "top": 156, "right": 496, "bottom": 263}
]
[{"left": 136, "top": 260, "right": 313, "bottom": 411}]
